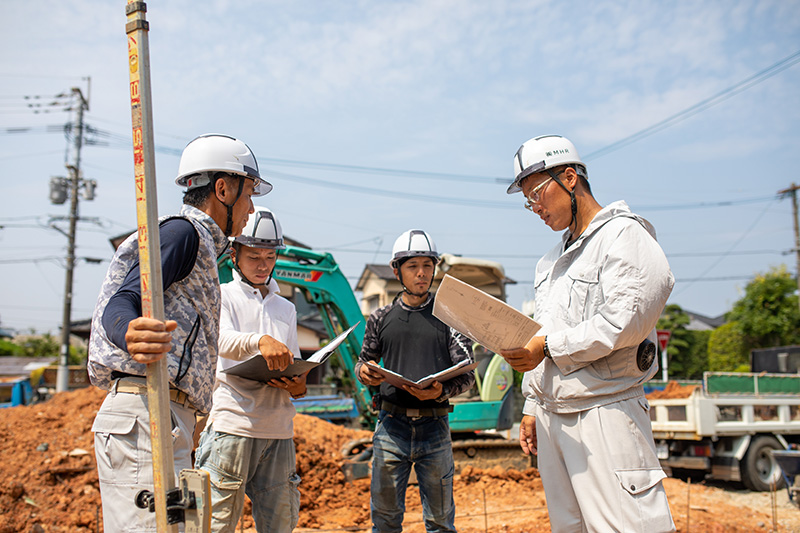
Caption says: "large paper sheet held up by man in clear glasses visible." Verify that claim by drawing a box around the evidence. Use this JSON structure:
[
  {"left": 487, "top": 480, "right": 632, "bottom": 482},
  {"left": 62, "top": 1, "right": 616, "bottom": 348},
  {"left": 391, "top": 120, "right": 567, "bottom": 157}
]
[{"left": 433, "top": 275, "right": 542, "bottom": 353}]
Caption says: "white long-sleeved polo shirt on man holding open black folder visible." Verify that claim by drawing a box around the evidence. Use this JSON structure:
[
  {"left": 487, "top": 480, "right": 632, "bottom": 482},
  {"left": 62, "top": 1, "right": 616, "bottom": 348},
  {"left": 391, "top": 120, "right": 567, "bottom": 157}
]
[{"left": 209, "top": 271, "right": 300, "bottom": 439}]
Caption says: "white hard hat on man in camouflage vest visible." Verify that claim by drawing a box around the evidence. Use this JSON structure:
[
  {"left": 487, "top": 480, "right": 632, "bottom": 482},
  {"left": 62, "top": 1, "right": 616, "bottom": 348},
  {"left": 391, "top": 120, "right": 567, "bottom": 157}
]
[{"left": 175, "top": 133, "right": 272, "bottom": 196}]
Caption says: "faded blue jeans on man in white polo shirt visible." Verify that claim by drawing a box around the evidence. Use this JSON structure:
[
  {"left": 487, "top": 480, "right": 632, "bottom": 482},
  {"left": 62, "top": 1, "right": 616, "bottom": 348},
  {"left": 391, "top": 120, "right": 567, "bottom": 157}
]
[{"left": 195, "top": 426, "right": 300, "bottom": 533}]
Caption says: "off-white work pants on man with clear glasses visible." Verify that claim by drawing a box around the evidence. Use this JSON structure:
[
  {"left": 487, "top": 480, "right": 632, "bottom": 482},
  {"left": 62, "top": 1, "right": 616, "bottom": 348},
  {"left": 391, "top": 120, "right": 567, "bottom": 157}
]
[{"left": 536, "top": 397, "right": 675, "bottom": 533}]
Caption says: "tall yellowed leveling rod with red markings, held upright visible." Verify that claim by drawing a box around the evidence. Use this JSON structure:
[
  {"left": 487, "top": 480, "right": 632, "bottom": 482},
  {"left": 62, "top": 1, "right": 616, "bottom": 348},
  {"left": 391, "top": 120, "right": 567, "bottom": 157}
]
[{"left": 125, "top": 0, "right": 211, "bottom": 533}]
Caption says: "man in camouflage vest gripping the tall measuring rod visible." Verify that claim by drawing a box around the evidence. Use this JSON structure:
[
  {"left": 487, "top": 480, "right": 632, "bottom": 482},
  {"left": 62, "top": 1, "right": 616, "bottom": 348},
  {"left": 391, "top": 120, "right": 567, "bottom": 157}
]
[{"left": 88, "top": 134, "right": 272, "bottom": 531}]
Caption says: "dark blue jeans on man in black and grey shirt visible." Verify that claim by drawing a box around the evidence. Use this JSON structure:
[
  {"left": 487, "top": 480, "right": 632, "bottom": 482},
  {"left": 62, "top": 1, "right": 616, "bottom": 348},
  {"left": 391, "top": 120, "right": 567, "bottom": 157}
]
[{"left": 370, "top": 411, "right": 456, "bottom": 533}]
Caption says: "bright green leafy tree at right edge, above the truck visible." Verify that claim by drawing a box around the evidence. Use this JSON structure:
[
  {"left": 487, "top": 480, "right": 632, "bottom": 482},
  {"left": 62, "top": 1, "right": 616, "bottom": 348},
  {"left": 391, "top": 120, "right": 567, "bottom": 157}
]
[{"left": 727, "top": 265, "right": 800, "bottom": 351}]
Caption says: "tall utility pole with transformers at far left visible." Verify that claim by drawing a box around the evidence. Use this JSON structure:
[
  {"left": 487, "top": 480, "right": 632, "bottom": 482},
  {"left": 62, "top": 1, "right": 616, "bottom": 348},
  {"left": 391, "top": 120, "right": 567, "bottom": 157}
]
[{"left": 56, "top": 87, "right": 89, "bottom": 392}]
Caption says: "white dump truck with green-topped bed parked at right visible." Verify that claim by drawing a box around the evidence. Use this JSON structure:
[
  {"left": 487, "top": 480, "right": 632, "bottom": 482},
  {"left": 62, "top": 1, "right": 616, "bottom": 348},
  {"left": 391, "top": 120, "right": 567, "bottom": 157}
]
[{"left": 648, "top": 372, "right": 800, "bottom": 491}]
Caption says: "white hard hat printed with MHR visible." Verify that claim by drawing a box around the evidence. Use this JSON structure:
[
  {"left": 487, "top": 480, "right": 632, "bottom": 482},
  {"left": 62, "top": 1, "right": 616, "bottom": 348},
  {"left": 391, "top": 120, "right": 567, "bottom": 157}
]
[{"left": 506, "top": 135, "right": 588, "bottom": 194}]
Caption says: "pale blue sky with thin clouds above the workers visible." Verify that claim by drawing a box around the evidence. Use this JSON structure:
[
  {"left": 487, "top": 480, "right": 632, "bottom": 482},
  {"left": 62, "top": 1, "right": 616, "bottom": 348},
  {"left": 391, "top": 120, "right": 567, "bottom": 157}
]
[{"left": 0, "top": 0, "right": 800, "bottom": 332}]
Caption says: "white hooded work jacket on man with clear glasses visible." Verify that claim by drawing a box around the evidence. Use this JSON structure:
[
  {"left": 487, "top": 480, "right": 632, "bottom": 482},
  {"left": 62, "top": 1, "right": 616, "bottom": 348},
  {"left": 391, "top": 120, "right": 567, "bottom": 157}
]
[{"left": 522, "top": 201, "right": 675, "bottom": 414}]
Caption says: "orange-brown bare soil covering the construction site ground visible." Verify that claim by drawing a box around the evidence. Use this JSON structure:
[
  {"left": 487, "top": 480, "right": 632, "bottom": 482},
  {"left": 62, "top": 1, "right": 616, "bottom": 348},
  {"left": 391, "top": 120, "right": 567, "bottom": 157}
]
[{"left": 0, "top": 387, "right": 800, "bottom": 533}]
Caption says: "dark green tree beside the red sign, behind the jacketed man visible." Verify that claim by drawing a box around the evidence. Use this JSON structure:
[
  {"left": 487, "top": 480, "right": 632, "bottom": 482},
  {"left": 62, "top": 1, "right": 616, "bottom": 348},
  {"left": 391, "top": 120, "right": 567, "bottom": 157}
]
[{"left": 657, "top": 304, "right": 709, "bottom": 379}]
